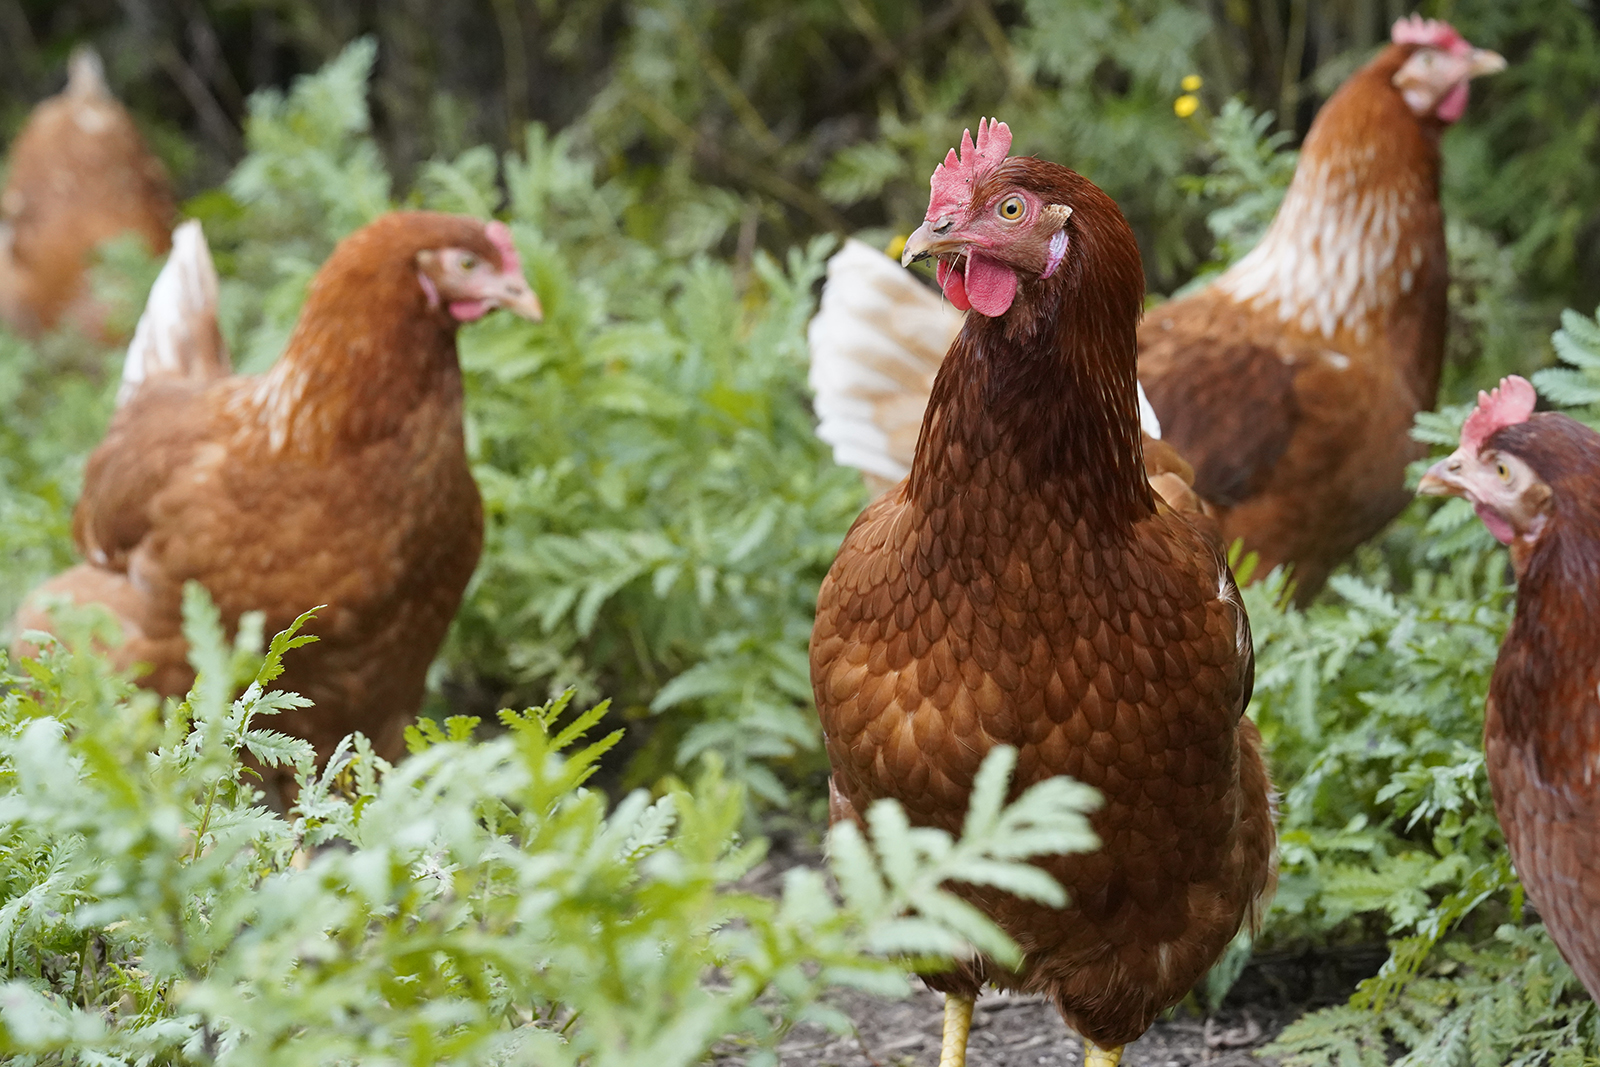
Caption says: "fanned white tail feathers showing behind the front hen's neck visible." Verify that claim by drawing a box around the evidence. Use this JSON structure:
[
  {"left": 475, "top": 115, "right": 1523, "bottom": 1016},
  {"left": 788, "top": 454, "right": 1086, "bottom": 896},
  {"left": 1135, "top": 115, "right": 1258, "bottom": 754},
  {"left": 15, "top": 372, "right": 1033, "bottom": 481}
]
[{"left": 806, "top": 240, "right": 1162, "bottom": 485}]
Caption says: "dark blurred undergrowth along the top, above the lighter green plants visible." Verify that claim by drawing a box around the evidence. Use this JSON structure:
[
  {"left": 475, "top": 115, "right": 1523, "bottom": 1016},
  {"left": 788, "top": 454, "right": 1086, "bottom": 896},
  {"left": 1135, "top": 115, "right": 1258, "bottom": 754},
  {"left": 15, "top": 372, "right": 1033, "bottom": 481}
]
[{"left": 0, "top": 0, "right": 1600, "bottom": 300}]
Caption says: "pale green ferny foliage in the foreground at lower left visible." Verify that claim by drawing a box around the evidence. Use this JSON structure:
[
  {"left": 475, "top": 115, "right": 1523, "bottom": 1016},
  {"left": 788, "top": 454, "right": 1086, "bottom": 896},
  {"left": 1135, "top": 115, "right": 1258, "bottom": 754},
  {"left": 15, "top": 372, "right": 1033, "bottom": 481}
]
[{"left": 0, "top": 585, "right": 1096, "bottom": 1067}]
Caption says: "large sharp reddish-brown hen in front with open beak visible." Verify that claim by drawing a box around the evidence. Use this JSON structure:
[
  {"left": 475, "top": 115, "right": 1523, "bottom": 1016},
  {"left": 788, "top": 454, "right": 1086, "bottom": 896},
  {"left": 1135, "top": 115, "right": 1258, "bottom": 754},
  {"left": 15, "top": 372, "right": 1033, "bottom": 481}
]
[{"left": 811, "top": 123, "right": 1275, "bottom": 1067}]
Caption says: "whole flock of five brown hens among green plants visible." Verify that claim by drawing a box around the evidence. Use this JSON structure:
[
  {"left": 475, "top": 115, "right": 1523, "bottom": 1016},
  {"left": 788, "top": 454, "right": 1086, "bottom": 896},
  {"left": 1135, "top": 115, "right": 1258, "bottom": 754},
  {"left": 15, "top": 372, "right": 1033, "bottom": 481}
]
[{"left": 0, "top": 16, "right": 1600, "bottom": 1067}]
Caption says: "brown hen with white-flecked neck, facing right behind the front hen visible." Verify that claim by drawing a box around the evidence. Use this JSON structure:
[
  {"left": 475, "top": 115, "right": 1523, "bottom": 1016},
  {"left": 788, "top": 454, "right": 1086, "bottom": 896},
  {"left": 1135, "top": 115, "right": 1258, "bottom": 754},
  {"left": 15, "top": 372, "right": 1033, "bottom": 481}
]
[{"left": 811, "top": 19, "right": 1504, "bottom": 601}]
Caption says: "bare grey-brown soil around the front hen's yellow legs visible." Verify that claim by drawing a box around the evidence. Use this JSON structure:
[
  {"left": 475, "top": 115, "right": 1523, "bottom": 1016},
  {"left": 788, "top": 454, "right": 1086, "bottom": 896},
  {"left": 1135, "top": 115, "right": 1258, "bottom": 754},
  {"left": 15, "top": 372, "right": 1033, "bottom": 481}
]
[{"left": 712, "top": 841, "right": 1387, "bottom": 1067}]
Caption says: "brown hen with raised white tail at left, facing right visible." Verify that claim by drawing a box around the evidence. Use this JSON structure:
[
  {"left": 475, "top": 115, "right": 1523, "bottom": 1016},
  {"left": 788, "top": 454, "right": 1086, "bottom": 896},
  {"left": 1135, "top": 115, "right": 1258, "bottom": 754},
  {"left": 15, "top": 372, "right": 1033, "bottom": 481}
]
[{"left": 16, "top": 213, "right": 539, "bottom": 777}]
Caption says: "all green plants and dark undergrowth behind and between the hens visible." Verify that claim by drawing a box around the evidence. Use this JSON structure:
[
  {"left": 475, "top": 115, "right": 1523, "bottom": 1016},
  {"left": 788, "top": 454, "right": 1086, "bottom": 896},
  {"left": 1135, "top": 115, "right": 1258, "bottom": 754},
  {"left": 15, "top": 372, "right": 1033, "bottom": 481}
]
[{"left": 0, "top": 0, "right": 1600, "bottom": 1064}]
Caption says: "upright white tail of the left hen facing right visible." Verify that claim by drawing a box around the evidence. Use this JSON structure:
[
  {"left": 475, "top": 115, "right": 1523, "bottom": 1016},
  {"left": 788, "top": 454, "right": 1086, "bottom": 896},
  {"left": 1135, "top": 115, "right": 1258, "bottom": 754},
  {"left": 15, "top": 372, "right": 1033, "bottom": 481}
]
[{"left": 117, "top": 219, "right": 232, "bottom": 408}]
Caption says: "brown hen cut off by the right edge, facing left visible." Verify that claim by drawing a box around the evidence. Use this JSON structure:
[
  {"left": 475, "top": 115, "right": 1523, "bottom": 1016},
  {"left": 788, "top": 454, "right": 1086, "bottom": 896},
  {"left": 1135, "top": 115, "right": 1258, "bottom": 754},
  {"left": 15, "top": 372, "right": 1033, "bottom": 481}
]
[{"left": 1418, "top": 378, "right": 1600, "bottom": 998}]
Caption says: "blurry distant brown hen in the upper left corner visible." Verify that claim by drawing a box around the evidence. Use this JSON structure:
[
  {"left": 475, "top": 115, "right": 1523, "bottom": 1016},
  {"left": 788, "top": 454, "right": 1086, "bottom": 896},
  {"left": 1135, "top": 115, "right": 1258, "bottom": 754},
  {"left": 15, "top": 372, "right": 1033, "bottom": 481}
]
[{"left": 0, "top": 48, "right": 174, "bottom": 334}]
